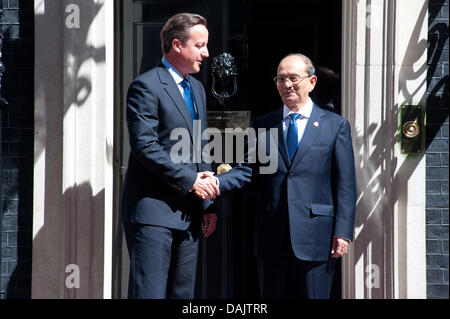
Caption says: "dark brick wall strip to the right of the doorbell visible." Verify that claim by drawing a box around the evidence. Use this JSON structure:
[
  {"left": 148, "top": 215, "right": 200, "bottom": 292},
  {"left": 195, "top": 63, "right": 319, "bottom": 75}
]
[{"left": 426, "top": 0, "right": 449, "bottom": 299}]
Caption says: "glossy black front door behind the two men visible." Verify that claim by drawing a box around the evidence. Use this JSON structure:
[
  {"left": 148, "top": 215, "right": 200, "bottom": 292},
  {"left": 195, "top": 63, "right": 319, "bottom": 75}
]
[{"left": 118, "top": 0, "right": 341, "bottom": 298}]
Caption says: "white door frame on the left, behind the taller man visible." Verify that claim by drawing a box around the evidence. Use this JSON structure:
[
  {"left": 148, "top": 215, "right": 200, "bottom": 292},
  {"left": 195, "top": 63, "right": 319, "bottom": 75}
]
[{"left": 31, "top": 0, "right": 115, "bottom": 298}]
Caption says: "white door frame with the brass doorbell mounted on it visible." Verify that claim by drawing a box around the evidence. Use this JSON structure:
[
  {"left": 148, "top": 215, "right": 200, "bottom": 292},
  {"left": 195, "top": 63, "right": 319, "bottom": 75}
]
[{"left": 342, "top": 0, "right": 428, "bottom": 299}]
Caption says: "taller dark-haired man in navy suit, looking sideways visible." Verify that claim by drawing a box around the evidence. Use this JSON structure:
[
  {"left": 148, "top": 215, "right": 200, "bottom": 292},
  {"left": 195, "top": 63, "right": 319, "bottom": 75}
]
[{"left": 122, "top": 13, "right": 218, "bottom": 298}]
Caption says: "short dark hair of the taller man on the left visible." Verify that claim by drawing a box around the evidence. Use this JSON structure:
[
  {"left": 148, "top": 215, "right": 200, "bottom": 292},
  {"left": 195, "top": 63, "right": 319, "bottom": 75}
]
[{"left": 160, "top": 13, "right": 206, "bottom": 54}]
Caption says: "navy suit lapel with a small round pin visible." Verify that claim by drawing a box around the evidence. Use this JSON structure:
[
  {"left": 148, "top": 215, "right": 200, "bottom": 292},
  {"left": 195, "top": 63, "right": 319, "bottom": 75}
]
[{"left": 290, "top": 104, "right": 324, "bottom": 170}]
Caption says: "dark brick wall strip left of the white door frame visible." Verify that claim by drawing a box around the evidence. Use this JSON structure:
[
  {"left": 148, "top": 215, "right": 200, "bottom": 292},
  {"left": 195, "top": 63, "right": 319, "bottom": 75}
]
[{"left": 1, "top": 0, "right": 34, "bottom": 298}]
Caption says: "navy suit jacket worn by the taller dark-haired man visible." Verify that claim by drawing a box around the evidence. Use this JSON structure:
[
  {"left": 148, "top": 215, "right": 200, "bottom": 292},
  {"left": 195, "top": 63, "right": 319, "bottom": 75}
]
[{"left": 122, "top": 65, "right": 211, "bottom": 230}]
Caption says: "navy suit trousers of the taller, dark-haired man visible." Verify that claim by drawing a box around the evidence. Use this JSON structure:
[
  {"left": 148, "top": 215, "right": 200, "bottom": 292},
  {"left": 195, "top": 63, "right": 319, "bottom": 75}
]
[{"left": 124, "top": 223, "right": 199, "bottom": 299}]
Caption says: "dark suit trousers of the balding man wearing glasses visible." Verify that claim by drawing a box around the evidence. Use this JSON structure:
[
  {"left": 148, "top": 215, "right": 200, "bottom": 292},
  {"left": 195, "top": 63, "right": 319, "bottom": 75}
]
[{"left": 257, "top": 252, "right": 335, "bottom": 299}]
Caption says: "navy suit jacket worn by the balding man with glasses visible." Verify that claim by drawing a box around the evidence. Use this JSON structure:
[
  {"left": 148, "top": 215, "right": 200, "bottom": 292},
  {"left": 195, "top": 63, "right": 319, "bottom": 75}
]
[{"left": 219, "top": 105, "right": 356, "bottom": 261}]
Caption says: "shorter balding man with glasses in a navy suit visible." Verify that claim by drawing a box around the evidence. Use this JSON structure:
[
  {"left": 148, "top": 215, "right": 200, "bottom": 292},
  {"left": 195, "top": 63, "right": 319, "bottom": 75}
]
[{"left": 218, "top": 54, "right": 356, "bottom": 298}]
